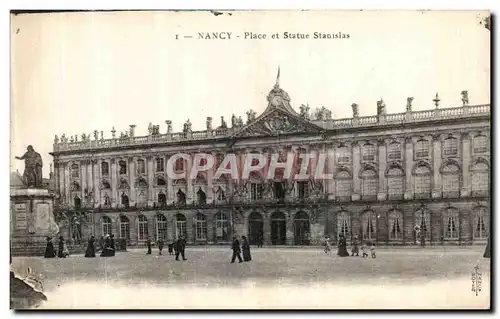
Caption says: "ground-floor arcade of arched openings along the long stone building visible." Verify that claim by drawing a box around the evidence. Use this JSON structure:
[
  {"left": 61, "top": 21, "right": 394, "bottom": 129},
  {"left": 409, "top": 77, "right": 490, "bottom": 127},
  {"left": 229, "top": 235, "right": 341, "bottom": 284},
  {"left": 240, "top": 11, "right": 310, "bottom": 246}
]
[{"left": 56, "top": 201, "right": 490, "bottom": 246}]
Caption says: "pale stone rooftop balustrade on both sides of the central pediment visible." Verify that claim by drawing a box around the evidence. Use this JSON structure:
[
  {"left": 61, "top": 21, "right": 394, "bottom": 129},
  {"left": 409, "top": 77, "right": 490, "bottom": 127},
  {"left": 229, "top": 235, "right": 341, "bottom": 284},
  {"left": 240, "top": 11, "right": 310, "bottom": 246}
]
[{"left": 54, "top": 104, "right": 490, "bottom": 152}]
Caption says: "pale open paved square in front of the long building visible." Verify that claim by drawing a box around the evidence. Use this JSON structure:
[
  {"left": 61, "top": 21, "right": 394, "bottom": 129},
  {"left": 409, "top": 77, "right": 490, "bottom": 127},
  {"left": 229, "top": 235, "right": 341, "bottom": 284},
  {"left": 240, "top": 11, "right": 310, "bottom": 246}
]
[{"left": 12, "top": 246, "right": 490, "bottom": 308}]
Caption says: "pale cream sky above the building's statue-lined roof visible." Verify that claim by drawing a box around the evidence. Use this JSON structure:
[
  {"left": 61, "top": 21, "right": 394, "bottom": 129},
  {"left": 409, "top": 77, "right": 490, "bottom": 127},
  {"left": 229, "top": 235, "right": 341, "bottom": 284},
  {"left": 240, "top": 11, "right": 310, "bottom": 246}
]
[{"left": 11, "top": 11, "right": 491, "bottom": 177}]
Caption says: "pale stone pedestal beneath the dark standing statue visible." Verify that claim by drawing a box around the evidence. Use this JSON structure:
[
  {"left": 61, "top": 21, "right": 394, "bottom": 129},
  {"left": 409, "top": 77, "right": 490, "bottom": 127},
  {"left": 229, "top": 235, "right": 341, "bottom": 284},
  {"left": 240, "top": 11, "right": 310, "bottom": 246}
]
[{"left": 10, "top": 188, "right": 59, "bottom": 256}]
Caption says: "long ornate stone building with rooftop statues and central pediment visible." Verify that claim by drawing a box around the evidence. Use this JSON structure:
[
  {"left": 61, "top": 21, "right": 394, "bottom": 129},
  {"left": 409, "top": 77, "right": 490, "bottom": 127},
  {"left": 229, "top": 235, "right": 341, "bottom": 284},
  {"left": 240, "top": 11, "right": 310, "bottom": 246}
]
[{"left": 48, "top": 76, "right": 491, "bottom": 249}]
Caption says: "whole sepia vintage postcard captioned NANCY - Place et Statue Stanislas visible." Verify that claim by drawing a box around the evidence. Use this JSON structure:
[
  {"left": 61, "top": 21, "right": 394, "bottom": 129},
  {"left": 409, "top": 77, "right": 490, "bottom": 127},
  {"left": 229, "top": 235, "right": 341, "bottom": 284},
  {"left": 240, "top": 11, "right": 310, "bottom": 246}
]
[{"left": 10, "top": 10, "right": 492, "bottom": 310}]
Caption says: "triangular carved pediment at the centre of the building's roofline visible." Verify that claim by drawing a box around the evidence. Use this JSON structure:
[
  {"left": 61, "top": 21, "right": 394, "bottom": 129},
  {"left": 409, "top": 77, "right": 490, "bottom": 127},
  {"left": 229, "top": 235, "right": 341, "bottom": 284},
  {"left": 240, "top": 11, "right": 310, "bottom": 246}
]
[{"left": 233, "top": 108, "right": 323, "bottom": 137}]
